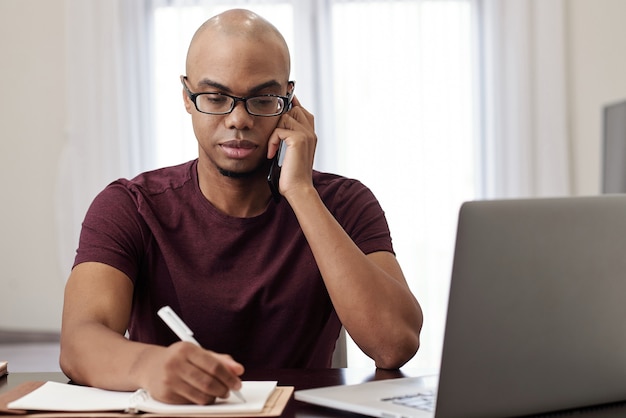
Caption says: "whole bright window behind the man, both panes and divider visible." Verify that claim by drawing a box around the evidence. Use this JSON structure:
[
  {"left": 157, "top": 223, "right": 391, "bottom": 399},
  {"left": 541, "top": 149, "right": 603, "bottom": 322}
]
[{"left": 154, "top": 0, "right": 479, "bottom": 369}]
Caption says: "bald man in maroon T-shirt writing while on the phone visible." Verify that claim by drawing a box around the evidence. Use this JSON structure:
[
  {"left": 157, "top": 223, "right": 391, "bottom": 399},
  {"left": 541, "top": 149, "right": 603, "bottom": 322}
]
[{"left": 60, "top": 10, "right": 422, "bottom": 404}]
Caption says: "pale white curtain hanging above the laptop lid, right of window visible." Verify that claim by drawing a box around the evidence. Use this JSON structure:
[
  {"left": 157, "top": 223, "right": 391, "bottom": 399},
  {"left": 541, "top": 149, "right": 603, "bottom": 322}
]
[{"left": 479, "top": 0, "right": 572, "bottom": 198}]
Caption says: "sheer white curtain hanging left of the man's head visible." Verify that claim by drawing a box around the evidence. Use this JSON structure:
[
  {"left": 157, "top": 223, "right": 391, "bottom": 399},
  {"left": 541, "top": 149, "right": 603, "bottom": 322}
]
[{"left": 56, "top": 0, "right": 153, "bottom": 275}]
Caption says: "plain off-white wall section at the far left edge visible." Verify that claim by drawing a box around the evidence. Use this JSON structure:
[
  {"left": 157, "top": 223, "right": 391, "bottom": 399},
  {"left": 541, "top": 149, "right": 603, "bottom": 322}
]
[{"left": 0, "top": 0, "right": 66, "bottom": 330}]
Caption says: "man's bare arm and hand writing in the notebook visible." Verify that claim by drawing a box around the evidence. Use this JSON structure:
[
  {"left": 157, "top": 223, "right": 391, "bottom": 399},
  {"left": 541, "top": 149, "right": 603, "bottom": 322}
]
[{"left": 60, "top": 263, "right": 243, "bottom": 404}]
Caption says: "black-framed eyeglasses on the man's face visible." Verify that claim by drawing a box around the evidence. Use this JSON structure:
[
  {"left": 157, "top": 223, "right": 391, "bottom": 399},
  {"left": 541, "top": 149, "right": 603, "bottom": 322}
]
[{"left": 180, "top": 76, "right": 295, "bottom": 116}]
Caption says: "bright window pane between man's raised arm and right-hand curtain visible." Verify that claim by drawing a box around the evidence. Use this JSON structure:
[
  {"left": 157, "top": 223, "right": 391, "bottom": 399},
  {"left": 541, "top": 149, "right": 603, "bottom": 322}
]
[{"left": 332, "top": 1, "right": 477, "bottom": 369}]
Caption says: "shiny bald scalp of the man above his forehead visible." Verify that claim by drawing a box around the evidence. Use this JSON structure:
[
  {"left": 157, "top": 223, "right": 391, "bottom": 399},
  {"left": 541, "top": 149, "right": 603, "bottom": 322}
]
[{"left": 186, "top": 9, "right": 291, "bottom": 74}]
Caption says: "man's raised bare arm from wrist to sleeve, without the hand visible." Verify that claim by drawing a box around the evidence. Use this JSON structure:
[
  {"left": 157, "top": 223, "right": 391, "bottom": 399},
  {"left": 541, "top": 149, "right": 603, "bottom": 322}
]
[{"left": 289, "top": 189, "right": 422, "bottom": 368}]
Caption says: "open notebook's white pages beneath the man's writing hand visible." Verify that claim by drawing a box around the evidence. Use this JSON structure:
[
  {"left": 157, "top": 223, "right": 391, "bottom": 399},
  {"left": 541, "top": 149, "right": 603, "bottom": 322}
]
[{"left": 8, "top": 381, "right": 277, "bottom": 415}]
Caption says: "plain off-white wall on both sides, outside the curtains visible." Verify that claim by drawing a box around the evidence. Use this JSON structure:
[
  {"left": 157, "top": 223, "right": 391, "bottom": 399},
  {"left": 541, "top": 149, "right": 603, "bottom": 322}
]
[{"left": 0, "top": 0, "right": 626, "bottom": 330}]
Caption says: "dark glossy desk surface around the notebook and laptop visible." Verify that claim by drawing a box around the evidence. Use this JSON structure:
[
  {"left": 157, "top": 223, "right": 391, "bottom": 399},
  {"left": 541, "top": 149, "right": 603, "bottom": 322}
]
[{"left": 0, "top": 368, "right": 419, "bottom": 418}]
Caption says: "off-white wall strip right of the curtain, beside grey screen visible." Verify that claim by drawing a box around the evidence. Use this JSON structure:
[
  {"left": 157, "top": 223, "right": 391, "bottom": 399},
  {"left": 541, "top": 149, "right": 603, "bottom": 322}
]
[{"left": 566, "top": 0, "right": 626, "bottom": 194}]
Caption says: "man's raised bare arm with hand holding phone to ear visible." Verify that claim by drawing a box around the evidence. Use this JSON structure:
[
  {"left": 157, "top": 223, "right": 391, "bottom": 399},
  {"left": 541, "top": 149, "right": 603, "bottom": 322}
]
[{"left": 268, "top": 99, "right": 423, "bottom": 368}]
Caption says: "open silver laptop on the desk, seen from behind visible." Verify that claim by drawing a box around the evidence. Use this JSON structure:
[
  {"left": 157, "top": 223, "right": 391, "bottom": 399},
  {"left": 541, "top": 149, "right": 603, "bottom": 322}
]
[{"left": 295, "top": 195, "right": 626, "bottom": 418}]
